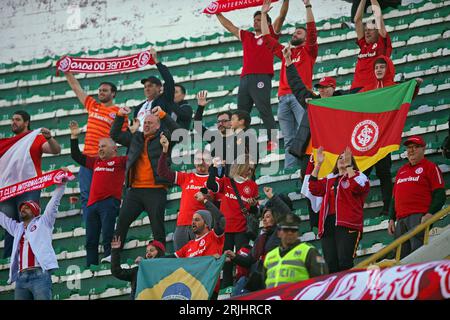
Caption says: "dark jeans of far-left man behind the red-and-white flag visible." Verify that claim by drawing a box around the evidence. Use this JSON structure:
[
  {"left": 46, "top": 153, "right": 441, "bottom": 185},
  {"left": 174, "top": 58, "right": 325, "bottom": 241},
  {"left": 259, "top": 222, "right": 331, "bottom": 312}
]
[{"left": 0, "top": 190, "right": 41, "bottom": 259}]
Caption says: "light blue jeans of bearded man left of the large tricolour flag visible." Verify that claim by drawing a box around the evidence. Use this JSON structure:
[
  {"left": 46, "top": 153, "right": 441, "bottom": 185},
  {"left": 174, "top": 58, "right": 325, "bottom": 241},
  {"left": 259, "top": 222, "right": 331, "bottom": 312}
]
[{"left": 277, "top": 94, "right": 306, "bottom": 169}]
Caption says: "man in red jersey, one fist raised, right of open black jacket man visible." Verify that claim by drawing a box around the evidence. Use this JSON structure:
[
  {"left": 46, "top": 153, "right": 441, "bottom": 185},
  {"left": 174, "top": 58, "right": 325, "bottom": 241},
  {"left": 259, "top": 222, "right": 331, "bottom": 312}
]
[{"left": 157, "top": 134, "right": 215, "bottom": 251}]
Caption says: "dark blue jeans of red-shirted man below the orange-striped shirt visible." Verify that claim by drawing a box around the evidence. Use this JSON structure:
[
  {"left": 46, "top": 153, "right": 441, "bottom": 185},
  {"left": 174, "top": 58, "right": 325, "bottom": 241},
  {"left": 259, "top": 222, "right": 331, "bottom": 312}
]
[{"left": 86, "top": 197, "right": 120, "bottom": 267}]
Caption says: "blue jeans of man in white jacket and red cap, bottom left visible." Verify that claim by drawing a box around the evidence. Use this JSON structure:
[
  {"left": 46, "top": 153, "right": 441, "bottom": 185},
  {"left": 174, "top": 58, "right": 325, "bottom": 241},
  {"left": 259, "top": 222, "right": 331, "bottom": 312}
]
[{"left": 14, "top": 268, "right": 52, "bottom": 300}]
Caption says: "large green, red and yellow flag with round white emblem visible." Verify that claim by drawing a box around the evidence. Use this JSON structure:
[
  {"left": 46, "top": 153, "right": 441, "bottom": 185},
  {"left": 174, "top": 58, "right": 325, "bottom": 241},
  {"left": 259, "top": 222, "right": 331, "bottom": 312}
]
[{"left": 308, "top": 80, "right": 416, "bottom": 178}]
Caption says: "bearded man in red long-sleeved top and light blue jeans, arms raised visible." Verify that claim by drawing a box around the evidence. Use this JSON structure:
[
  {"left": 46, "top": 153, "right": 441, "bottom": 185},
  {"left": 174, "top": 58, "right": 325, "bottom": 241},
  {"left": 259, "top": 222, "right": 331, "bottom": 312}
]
[{"left": 261, "top": 0, "right": 319, "bottom": 169}]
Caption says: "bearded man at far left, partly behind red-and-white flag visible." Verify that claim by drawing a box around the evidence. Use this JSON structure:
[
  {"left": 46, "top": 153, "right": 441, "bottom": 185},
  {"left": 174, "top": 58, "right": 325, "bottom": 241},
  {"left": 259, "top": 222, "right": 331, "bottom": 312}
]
[{"left": 0, "top": 110, "right": 61, "bottom": 258}]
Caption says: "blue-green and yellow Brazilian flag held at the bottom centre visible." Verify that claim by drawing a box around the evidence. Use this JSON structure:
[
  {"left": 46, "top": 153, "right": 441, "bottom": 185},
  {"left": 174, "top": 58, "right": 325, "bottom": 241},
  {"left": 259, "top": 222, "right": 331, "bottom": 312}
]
[{"left": 136, "top": 255, "right": 225, "bottom": 300}]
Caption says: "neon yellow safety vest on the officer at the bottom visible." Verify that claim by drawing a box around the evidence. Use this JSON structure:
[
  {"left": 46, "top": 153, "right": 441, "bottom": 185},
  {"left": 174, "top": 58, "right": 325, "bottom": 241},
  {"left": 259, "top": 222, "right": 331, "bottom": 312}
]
[{"left": 264, "top": 243, "right": 312, "bottom": 288}]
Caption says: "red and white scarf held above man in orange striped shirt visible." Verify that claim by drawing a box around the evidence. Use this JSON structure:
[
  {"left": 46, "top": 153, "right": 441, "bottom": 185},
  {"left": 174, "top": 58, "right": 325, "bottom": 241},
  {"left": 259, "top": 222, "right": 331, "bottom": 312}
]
[{"left": 56, "top": 50, "right": 155, "bottom": 75}]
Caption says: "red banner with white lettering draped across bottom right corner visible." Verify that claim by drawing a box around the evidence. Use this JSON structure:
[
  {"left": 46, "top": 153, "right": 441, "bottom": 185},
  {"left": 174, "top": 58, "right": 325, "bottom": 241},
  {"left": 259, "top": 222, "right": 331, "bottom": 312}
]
[{"left": 234, "top": 260, "right": 450, "bottom": 300}]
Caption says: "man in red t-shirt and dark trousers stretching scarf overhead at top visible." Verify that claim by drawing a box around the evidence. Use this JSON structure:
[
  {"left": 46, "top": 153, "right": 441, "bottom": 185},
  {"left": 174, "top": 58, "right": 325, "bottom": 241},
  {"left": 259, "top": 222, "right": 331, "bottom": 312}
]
[{"left": 216, "top": 0, "right": 289, "bottom": 152}]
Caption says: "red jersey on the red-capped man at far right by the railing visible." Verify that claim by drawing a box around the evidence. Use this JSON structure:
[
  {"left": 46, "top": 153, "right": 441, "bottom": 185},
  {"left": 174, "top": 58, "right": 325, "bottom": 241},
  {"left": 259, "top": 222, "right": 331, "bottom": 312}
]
[{"left": 393, "top": 158, "right": 445, "bottom": 219}]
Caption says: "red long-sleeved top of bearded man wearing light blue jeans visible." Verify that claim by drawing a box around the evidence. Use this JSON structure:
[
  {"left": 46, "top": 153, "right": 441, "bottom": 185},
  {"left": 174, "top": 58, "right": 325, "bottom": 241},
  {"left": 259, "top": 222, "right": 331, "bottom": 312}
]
[{"left": 264, "top": 22, "right": 319, "bottom": 97}]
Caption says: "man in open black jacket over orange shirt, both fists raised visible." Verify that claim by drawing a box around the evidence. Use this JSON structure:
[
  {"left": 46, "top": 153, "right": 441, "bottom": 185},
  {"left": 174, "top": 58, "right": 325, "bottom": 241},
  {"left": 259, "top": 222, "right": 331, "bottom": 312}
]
[{"left": 110, "top": 106, "right": 180, "bottom": 251}]
